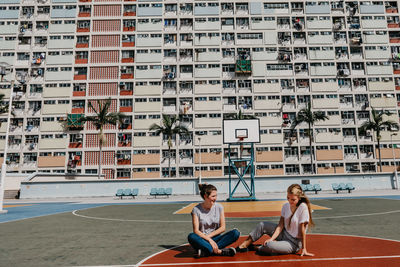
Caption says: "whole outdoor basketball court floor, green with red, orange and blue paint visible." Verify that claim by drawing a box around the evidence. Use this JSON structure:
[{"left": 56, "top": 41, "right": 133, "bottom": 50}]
[{"left": 0, "top": 195, "right": 400, "bottom": 267}]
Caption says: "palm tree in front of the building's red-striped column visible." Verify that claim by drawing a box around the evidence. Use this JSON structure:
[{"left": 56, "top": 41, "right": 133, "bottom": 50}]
[{"left": 78, "top": 99, "right": 125, "bottom": 179}]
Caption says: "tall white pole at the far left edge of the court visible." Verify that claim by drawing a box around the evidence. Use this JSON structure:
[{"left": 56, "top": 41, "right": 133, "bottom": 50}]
[{"left": 0, "top": 62, "right": 14, "bottom": 214}]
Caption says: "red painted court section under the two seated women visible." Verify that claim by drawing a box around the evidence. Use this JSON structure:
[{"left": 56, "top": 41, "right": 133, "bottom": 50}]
[{"left": 137, "top": 234, "right": 400, "bottom": 267}]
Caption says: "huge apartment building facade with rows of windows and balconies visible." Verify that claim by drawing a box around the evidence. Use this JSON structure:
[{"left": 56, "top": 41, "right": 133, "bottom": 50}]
[{"left": 0, "top": 0, "right": 400, "bottom": 179}]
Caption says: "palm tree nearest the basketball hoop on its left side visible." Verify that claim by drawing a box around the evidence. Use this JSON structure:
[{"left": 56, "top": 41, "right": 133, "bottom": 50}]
[{"left": 149, "top": 114, "right": 189, "bottom": 177}]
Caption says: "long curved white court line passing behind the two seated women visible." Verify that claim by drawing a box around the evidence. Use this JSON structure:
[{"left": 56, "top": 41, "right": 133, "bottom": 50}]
[{"left": 72, "top": 208, "right": 400, "bottom": 223}]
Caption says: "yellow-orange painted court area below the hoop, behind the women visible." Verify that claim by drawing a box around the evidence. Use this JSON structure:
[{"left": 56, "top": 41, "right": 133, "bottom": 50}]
[{"left": 174, "top": 200, "right": 329, "bottom": 218}]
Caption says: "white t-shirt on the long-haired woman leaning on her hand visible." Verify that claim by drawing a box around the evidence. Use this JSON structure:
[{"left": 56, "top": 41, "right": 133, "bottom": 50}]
[{"left": 281, "top": 203, "right": 310, "bottom": 238}]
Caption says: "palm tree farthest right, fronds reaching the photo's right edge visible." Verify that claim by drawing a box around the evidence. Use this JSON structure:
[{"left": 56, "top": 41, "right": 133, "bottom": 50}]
[{"left": 359, "top": 108, "right": 399, "bottom": 172}]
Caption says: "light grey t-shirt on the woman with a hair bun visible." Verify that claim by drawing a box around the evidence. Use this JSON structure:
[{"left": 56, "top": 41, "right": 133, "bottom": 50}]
[{"left": 192, "top": 203, "right": 224, "bottom": 235}]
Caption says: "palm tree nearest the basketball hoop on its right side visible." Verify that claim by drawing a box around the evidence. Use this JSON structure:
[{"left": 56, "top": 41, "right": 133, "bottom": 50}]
[{"left": 291, "top": 102, "right": 328, "bottom": 173}]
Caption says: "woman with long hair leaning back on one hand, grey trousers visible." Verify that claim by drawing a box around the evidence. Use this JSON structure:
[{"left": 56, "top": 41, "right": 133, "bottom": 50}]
[{"left": 236, "top": 184, "right": 314, "bottom": 256}]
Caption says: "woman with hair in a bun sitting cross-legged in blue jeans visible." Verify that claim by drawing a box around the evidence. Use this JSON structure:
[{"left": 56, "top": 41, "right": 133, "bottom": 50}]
[{"left": 188, "top": 184, "right": 240, "bottom": 257}]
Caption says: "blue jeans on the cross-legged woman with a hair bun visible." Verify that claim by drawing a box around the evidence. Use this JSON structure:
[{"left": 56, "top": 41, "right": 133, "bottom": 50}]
[{"left": 188, "top": 229, "right": 240, "bottom": 255}]
